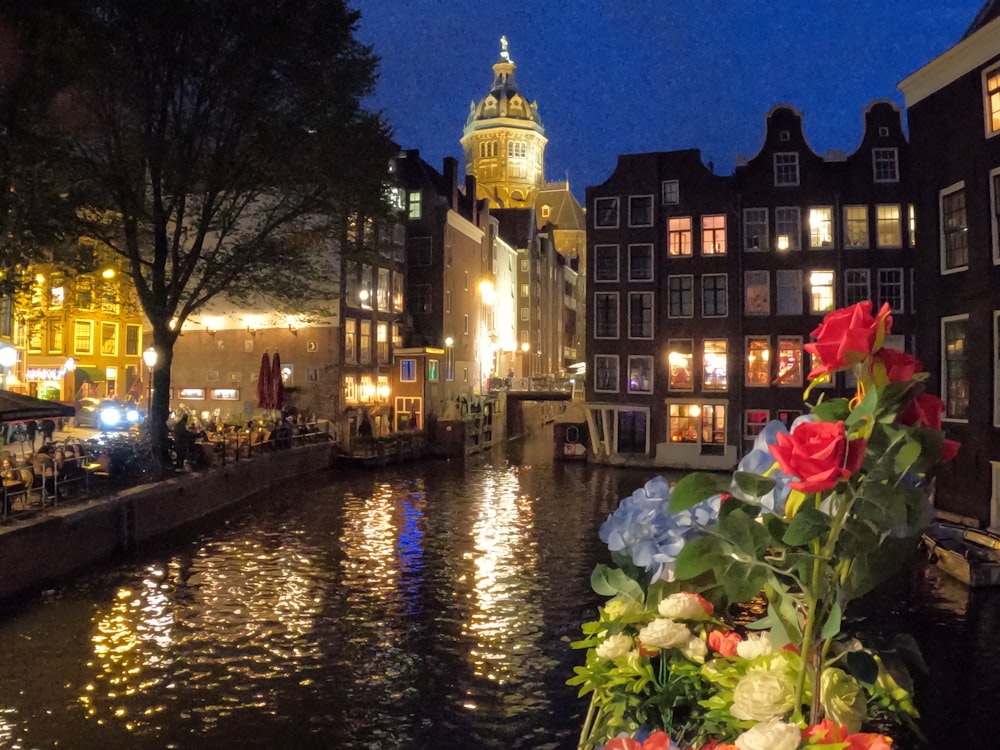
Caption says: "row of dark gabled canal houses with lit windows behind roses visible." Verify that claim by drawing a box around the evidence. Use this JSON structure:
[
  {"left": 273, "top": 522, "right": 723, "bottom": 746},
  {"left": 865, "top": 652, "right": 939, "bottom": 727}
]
[{"left": 586, "top": 102, "right": 915, "bottom": 469}]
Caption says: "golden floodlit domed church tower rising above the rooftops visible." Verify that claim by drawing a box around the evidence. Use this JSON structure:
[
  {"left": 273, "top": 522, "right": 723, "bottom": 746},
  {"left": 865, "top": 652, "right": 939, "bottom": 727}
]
[{"left": 461, "top": 36, "right": 548, "bottom": 208}]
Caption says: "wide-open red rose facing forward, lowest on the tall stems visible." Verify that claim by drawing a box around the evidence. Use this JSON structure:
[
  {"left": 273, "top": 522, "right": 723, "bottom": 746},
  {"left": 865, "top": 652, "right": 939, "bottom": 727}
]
[{"left": 770, "top": 421, "right": 865, "bottom": 492}]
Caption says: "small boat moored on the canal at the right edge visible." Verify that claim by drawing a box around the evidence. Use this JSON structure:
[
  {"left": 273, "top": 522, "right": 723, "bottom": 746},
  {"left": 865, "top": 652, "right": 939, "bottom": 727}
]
[{"left": 921, "top": 522, "right": 1000, "bottom": 588}]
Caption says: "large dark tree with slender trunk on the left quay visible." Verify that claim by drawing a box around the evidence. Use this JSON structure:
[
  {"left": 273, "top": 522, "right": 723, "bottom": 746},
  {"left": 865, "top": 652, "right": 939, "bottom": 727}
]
[{"left": 12, "top": 0, "right": 393, "bottom": 462}]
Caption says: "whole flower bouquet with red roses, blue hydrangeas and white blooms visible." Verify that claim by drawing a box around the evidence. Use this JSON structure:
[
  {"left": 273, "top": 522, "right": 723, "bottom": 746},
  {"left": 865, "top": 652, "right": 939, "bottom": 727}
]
[{"left": 568, "top": 302, "right": 958, "bottom": 750}]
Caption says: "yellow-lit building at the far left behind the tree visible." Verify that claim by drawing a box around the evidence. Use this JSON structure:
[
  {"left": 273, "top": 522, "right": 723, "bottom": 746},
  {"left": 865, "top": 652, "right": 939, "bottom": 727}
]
[{"left": 5, "top": 264, "right": 145, "bottom": 402}]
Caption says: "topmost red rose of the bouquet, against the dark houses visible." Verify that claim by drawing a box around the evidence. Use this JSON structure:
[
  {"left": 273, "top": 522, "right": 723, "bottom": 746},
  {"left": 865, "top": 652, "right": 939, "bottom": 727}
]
[{"left": 803, "top": 300, "right": 892, "bottom": 380}]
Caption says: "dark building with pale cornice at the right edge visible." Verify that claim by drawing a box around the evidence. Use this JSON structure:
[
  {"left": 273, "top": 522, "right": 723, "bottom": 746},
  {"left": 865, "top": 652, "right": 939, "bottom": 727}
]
[{"left": 900, "top": 0, "right": 1000, "bottom": 528}]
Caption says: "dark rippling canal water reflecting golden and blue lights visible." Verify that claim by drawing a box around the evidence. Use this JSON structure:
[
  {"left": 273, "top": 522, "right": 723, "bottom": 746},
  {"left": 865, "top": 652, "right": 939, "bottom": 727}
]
[{"left": 0, "top": 431, "right": 1000, "bottom": 750}]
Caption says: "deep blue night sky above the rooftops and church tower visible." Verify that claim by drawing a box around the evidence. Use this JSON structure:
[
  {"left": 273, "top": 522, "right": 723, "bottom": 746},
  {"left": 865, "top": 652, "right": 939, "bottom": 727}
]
[{"left": 348, "top": 0, "right": 984, "bottom": 200}]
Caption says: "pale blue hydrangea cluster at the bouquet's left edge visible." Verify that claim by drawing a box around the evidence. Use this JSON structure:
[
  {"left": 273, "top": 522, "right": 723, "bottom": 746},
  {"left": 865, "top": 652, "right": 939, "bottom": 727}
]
[{"left": 600, "top": 476, "right": 722, "bottom": 581}]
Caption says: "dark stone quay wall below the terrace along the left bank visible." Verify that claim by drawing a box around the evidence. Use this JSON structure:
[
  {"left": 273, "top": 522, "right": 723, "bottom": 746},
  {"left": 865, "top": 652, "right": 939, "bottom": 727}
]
[{"left": 0, "top": 443, "right": 332, "bottom": 599}]
